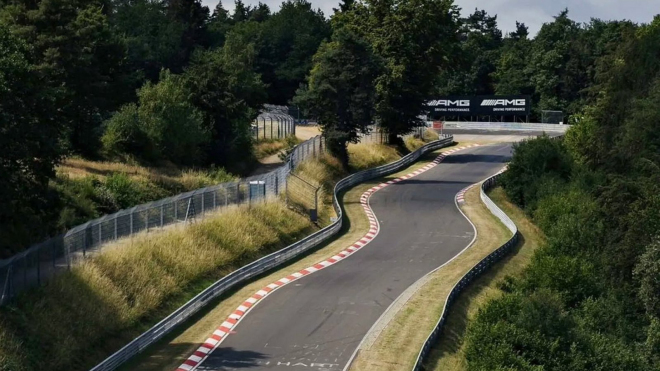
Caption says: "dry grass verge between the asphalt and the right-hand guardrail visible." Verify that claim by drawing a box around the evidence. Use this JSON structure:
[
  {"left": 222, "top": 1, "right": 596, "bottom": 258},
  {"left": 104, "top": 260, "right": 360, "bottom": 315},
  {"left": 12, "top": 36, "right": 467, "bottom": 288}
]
[{"left": 351, "top": 187, "right": 511, "bottom": 371}]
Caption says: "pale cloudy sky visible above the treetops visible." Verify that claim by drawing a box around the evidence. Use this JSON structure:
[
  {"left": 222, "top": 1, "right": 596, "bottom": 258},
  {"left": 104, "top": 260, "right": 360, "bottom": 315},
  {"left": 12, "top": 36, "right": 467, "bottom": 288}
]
[{"left": 208, "top": 0, "right": 660, "bottom": 35}]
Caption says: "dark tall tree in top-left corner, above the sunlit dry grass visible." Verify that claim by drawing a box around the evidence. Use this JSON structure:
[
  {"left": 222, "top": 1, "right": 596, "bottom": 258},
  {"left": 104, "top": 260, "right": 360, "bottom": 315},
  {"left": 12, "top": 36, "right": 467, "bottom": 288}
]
[{"left": 0, "top": 0, "right": 129, "bottom": 156}]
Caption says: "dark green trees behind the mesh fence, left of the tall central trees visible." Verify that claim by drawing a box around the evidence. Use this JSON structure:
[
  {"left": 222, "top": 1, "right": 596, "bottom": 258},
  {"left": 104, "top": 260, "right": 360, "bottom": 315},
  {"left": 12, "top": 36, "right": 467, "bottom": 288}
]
[{"left": 0, "top": 0, "right": 331, "bottom": 258}]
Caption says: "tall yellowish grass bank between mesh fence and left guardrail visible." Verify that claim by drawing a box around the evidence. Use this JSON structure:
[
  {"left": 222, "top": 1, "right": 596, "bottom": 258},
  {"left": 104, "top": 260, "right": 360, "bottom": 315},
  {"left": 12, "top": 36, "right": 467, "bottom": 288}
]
[{"left": 0, "top": 202, "right": 313, "bottom": 371}]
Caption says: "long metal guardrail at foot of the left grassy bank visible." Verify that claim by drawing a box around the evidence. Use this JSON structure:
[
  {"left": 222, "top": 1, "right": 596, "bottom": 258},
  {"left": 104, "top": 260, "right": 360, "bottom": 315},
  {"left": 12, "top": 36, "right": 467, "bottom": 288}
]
[{"left": 92, "top": 136, "right": 453, "bottom": 371}]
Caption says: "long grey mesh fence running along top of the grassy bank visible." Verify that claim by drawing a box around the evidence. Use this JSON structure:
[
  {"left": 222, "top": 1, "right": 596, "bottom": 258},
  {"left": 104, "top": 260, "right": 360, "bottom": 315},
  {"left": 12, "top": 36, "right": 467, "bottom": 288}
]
[{"left": 0, "top": 136, "right": 325, "bottom": 305}]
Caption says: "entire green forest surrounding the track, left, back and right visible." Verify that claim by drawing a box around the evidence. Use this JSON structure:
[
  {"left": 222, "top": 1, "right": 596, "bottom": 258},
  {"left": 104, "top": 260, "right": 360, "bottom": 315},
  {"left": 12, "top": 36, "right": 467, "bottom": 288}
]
[{"left": 0, "top": 0, "right": 660, "bottom": 371}]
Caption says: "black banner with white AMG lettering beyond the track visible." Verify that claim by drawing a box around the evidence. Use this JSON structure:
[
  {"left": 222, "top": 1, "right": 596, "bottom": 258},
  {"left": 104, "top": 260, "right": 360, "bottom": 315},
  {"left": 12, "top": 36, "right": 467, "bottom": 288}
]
[{"left": 427, "top": 95, "right": 532, "bottom": 118}]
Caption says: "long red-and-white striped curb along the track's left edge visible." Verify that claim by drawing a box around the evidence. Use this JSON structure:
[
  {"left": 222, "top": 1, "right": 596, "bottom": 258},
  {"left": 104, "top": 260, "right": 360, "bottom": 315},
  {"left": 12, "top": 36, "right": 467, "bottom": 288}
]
[{"left": 177, "top": 144, "right": 479, "bottom": 371}]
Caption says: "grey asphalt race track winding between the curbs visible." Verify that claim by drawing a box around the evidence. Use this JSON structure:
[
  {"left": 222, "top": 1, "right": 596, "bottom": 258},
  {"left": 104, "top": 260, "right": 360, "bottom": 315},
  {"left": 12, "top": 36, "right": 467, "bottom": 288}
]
[{"left": 197, "top": 143, "right": 511, "bottom": 371}]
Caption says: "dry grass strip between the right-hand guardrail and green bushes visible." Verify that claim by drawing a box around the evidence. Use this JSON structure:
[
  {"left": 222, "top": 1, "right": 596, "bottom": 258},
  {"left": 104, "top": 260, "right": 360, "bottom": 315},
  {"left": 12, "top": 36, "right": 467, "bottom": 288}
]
[{"left": 426, "top": 188, "right": 545, "bottom": 371}]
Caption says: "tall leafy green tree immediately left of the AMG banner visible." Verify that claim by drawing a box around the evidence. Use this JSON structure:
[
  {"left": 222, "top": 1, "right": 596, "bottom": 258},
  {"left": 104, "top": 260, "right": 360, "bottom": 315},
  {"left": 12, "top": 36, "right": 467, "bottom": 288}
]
[{"left": 346, "top": 0, "right": 458, "bottom": 143}]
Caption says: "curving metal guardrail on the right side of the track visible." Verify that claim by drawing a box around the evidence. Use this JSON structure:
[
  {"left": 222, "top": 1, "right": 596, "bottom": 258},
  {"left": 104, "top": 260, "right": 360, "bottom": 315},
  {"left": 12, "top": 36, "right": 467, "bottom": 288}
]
[{"left": 413, "top": 173, "right": 519, "bottom": 371}]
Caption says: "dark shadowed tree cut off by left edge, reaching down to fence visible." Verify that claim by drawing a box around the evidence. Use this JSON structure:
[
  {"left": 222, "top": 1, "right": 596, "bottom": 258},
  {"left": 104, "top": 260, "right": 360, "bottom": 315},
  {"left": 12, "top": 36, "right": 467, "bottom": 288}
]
[{"left": 0, "top": 25, "right": 61, "bottom": 258}]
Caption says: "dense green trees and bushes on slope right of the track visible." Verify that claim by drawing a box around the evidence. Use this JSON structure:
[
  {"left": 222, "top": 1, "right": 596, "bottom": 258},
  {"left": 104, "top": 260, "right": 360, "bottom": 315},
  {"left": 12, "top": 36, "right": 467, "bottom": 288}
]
[{"left": 466, "top": 17, "right": 660, "bottom": 371}]
